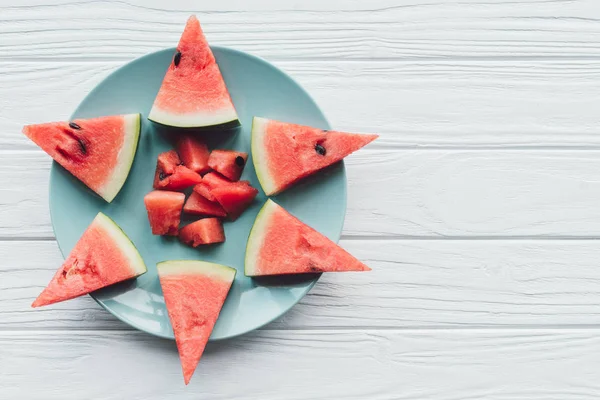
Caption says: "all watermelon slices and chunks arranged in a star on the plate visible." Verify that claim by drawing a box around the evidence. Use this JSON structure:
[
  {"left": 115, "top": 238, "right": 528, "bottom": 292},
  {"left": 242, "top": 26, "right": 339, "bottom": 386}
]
[{"left": 23, "top": 16, "right": 377, "bottom": 384}]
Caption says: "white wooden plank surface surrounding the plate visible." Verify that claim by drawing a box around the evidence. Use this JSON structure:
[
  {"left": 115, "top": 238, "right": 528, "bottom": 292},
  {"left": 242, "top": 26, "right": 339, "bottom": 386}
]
[{"left": 0, "top": 0, "right": 600, "bottom": 400}]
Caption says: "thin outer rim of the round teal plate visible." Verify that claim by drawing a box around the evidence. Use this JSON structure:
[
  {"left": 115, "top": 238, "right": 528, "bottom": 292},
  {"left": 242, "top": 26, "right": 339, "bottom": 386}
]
[{"left": 48, "top": 45, "right": 348, "bottom": 342}]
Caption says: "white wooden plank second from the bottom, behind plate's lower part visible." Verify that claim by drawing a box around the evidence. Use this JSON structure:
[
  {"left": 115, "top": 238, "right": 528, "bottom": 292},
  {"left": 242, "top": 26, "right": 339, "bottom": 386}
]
[{"left": 5, "top": 240, "right": 600, "bottom": 331}]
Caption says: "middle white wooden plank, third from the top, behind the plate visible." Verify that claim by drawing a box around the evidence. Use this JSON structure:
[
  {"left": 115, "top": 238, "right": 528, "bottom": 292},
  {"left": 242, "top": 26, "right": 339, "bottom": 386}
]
[{"left": 0, "top": 149, "right": 600, "bottom": 238}]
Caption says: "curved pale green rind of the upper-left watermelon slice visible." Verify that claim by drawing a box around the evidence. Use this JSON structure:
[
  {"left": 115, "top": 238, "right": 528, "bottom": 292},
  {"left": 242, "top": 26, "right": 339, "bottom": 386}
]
[{"left": 98, "top": 114, "right": 141, "bottom": 203}]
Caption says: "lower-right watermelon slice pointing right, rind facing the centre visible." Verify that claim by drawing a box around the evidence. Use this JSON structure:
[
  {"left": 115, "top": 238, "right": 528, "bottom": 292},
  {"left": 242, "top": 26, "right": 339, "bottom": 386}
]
[{"left": 245, "top": 199, "right": 370, "bottom": 276}]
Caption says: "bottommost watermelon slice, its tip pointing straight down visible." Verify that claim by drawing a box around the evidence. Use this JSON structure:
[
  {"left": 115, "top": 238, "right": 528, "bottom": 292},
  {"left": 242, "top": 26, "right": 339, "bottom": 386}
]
[{"left": 156, "top": 260, "right": 236, "bottom": 385}]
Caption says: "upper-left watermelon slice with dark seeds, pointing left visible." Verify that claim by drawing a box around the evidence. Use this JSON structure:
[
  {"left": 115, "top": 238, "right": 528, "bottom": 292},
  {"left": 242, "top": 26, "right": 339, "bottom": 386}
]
[{"left": 23, "top": 114, "right": 140, "bottom": 203}]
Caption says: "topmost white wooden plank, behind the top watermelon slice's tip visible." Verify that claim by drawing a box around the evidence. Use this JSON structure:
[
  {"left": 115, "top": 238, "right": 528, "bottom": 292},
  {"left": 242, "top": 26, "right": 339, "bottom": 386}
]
[{"left": 0, "top": 0, "right": 600, "bottom": 60}]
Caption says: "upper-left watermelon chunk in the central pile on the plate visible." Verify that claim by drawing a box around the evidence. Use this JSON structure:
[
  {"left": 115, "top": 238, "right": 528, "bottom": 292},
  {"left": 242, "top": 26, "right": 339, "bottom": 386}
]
[{"left": 154, "top": 150, "right": 202, "bottom": 191}]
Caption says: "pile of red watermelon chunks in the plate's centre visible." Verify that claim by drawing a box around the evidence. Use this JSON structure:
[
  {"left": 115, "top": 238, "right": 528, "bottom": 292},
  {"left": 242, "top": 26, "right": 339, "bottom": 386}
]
[{"left": 144, "top": 135, "right": 258, "bottom": 247}]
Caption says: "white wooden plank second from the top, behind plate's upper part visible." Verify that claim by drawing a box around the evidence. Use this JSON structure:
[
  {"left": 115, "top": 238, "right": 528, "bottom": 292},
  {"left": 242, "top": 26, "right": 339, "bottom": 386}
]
[{"left": 0, "top": 61, "right": 600, "bottom": 150}]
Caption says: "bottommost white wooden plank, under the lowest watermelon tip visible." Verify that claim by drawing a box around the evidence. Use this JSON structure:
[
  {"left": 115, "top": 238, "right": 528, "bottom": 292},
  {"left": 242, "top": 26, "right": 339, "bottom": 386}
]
[{"left": 0, "top": 329, "right": 600, "bottom": 400}]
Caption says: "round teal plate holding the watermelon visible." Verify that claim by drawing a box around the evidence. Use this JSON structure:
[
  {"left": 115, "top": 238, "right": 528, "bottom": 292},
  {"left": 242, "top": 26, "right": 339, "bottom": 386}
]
[{"left": 50, "top": 47, "right": 346, "bottom": 340}]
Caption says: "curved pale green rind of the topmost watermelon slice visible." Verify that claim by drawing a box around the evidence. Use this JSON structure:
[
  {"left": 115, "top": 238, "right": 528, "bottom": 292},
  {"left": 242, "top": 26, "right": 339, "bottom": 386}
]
[{"left": 148, "top": 106, "right": 240, "bottom": 128}]
